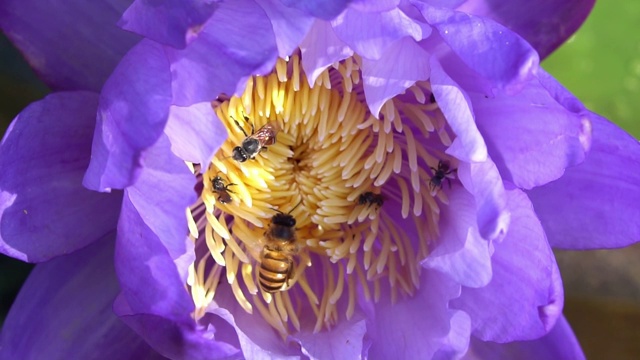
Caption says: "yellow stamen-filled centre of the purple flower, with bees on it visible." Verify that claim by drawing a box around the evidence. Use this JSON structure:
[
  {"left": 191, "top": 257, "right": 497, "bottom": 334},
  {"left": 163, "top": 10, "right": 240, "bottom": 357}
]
[{"left": 187, "top": 55, "right": 455, "bottom": 336}]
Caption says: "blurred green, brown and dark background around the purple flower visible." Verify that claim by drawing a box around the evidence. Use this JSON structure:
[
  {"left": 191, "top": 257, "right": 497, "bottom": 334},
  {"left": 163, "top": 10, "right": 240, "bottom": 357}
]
[{"left": 0, "top": 0, "right": 640, "bottom": 359}]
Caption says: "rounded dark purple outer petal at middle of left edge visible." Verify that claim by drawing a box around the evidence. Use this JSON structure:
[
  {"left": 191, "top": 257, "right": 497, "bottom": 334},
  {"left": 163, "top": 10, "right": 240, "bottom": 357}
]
[{"left": 0, "top": 92, "right": 122, "bottom": 262}]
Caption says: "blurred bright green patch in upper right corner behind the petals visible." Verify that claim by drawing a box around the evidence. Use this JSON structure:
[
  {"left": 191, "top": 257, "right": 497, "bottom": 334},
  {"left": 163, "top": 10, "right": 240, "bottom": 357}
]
[{"left": 542, "top": 0, "right": 640, "bottom": 138}]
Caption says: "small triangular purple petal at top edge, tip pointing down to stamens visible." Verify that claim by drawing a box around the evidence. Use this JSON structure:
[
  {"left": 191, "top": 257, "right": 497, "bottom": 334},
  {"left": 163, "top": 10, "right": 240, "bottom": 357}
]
[{"left": 256, "top": 0, "right": 314, "bottom": 59}]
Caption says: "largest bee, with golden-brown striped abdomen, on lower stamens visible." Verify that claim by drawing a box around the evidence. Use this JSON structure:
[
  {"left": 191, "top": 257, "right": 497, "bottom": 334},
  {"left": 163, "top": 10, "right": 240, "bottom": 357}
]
[{"left": 258, "top": 203, "right": 300, "bottom": 293}]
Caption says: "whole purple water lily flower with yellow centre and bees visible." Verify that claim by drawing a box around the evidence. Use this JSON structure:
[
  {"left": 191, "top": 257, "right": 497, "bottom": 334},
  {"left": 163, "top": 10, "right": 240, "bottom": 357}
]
[{"left": 0, "top": 0, "right": 640, "bottom": 359}]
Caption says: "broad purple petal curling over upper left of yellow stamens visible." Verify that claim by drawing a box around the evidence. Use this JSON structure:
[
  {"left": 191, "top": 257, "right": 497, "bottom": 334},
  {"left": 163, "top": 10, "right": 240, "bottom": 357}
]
[{"left": 165, "top": 0, "right": 278, "bottom": 106}]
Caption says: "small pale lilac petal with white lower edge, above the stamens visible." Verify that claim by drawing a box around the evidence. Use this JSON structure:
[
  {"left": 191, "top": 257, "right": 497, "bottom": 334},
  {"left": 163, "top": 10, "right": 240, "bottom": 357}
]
[{"left": 300, "top": 20, "right": 353, "bottom": 85}]
